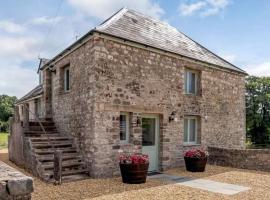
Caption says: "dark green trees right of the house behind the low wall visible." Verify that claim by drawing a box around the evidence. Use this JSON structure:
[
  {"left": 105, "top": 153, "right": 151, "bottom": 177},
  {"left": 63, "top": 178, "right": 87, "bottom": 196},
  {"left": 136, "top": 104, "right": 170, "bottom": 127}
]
[{"left": 246, "top": 76, "right": 270, "bottom": 144}]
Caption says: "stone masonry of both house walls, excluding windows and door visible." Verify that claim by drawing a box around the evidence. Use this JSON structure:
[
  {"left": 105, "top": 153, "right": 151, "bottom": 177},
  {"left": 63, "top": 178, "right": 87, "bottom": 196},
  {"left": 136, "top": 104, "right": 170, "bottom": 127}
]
[{"left": 47, "top": 35, "right": 245, "bottom": 177}]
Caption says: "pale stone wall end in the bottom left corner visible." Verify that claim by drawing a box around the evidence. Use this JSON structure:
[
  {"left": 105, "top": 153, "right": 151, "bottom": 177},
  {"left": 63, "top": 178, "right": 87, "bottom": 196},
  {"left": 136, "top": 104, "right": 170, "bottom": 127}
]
[{"left": 0, "top": 161, "right": 33, "bottom": 200}]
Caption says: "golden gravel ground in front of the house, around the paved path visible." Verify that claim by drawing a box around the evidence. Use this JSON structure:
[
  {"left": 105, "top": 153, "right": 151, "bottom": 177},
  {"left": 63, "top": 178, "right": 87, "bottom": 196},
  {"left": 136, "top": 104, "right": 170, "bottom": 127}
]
[{"left": 0, "top": 153, "right": 270, "bottom": 200}]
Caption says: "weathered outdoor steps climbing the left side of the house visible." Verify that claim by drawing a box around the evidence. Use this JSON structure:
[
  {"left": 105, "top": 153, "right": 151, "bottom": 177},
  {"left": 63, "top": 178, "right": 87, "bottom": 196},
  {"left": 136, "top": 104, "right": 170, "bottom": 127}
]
[{"left": 24, "top": 119, "right": 89, "bottom": 182}]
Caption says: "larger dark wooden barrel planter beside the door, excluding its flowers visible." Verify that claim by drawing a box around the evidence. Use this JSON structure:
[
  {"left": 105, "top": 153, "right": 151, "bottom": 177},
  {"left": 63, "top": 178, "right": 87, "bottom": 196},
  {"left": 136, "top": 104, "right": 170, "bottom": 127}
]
[{"left": 119, "top": 163, "right": 149, "bottom": 184}]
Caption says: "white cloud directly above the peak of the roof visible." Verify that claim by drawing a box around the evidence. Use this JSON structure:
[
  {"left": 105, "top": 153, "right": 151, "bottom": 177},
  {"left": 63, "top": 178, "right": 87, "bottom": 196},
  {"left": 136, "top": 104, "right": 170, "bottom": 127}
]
[{"left": 69, "top": 0, "right": 164, "bottom": 19}]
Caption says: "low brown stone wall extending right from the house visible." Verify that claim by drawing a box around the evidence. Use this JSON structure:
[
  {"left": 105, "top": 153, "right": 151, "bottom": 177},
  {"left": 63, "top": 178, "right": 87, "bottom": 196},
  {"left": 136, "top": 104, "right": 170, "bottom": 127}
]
[{"left": 208, "top": 147, "right": 270, "bottom": 171}]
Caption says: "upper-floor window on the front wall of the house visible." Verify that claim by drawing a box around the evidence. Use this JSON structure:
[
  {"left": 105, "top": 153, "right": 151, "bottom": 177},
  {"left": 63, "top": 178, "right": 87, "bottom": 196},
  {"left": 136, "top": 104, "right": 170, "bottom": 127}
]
[{"left": 185, "top": 70, "right": 198, "bottom": 94}]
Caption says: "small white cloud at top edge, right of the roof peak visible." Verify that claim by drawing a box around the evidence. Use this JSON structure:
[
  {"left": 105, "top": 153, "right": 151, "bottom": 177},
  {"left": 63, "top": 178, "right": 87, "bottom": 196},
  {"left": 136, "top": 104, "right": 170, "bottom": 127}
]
[{"left": 178, "top": 0, "right": 232, "bottom": 17}]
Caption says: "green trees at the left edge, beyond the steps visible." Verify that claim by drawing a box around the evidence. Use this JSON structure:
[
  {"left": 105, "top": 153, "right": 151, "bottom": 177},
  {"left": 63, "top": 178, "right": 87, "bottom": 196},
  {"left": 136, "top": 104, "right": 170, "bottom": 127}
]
[{"left": 0, "top": 95, "right": 17, "bottom": 131}]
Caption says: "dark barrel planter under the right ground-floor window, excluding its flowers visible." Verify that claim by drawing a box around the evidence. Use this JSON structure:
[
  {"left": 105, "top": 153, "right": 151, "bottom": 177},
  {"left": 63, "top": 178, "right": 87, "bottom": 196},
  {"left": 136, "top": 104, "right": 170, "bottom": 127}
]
[{"left": 184, "top": 157, "right": 207, "bottom": 172}]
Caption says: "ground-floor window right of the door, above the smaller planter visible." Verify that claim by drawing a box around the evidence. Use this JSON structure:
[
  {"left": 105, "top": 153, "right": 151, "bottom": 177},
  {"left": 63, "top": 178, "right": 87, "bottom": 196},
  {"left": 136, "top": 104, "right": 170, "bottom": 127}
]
[{"left": 184, "top": 117, "right": 198, "bottom": 144}]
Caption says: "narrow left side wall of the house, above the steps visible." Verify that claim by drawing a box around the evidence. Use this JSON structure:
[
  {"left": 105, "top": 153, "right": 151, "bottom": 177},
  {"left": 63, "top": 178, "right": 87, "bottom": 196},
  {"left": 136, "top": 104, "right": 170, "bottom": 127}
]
[{"left": 51, "top": 37, "right": 95, "bottom": 168}]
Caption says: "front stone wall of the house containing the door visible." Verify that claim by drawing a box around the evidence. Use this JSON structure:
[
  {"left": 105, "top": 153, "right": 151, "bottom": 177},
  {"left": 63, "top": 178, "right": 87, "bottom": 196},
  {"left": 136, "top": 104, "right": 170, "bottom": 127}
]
[{"left": 91, "top": 35, "right": 245, "bottom": 174}]
